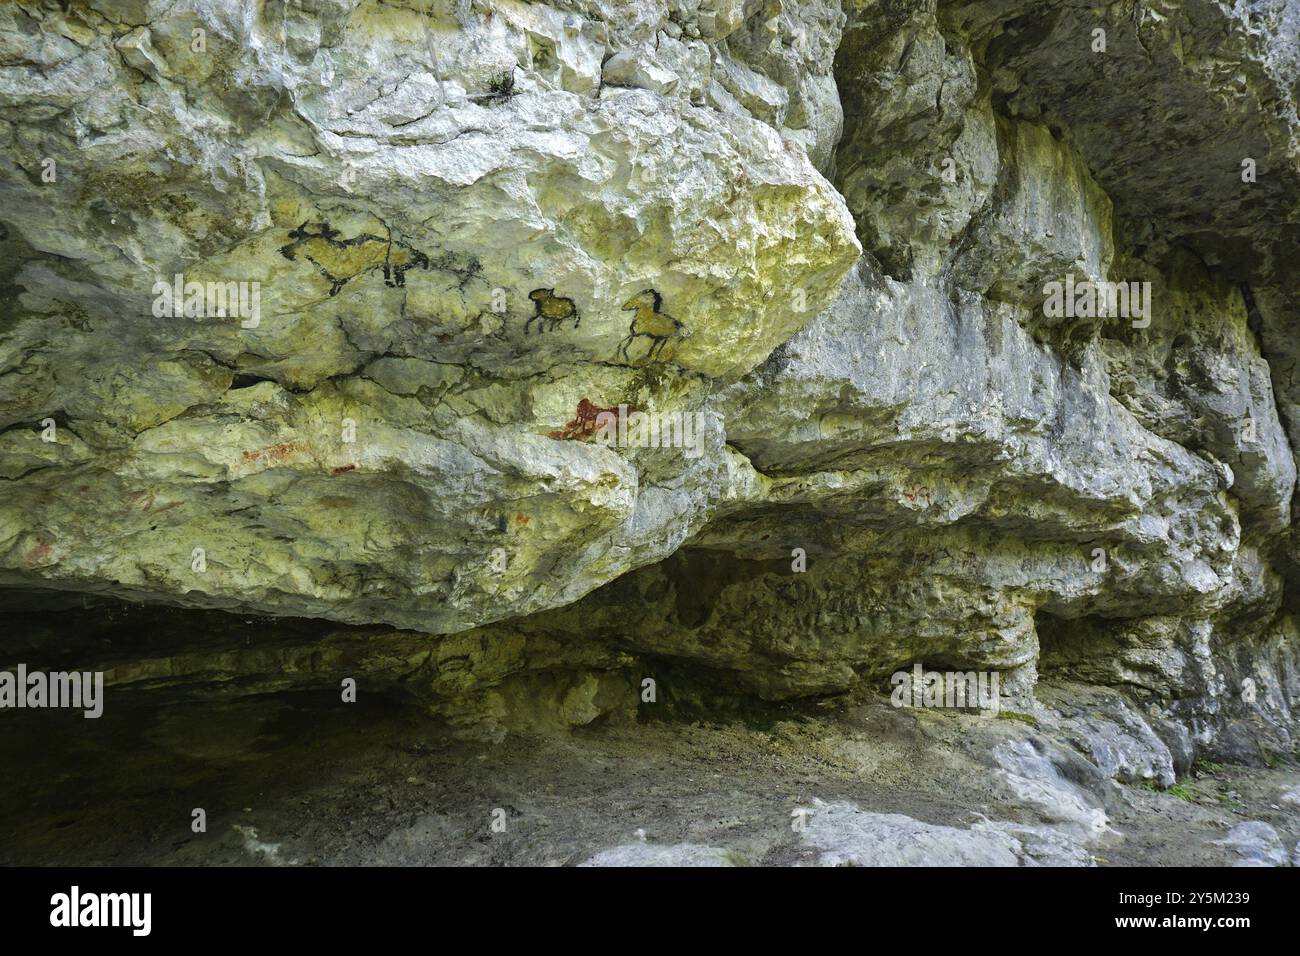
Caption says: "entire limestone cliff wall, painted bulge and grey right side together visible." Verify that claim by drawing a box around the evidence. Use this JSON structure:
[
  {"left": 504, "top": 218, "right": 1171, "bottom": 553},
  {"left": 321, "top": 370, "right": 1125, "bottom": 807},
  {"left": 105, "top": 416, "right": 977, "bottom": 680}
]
[{"left": 0, "top": 0, "right": 1300, "bottom": 764}]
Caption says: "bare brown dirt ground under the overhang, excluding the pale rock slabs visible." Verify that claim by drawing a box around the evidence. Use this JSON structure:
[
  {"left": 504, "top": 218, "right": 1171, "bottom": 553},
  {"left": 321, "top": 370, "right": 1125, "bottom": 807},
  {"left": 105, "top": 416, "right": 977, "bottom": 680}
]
[{"left": 0, "top": 693, "right": 1300, "bottom": 866}]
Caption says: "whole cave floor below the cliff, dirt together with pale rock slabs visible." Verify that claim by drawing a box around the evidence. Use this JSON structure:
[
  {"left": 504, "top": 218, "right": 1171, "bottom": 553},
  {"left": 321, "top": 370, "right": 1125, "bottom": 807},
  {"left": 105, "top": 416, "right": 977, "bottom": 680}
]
[{"left": 0, "top": 613, "right": 1300, "bottom": 866}]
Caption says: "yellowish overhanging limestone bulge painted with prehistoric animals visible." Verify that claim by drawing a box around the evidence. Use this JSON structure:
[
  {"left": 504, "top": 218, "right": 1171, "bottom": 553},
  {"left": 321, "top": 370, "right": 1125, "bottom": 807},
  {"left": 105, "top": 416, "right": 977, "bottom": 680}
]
[{"left": 0, "top": 0, "right": 859, "bottom": 632}]
